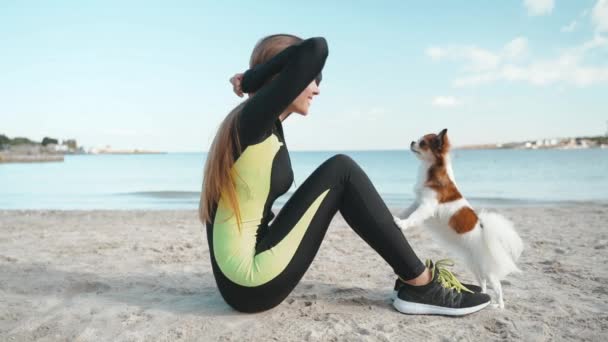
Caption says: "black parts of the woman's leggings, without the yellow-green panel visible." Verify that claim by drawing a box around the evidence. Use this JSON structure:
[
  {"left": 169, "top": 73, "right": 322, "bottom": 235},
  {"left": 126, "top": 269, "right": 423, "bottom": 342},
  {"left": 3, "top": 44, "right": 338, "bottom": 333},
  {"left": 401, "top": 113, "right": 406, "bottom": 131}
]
[{"left": 207, "top": 154, "right": 425, "bottom": 312}]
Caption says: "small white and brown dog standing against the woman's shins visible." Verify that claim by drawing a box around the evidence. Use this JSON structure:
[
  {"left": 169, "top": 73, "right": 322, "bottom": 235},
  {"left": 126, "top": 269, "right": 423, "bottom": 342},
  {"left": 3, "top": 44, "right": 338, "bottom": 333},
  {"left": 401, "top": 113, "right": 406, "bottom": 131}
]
[{"left": 395, "top": 129, "right": 523, "bottom": 309}]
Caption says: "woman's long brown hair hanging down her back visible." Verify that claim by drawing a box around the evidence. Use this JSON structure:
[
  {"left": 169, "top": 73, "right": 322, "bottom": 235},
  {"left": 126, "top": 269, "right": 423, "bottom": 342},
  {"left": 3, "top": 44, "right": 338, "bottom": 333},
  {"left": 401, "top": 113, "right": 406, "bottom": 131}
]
[{"left": 199, "top": 34, "right": 302, "bottom": 229}]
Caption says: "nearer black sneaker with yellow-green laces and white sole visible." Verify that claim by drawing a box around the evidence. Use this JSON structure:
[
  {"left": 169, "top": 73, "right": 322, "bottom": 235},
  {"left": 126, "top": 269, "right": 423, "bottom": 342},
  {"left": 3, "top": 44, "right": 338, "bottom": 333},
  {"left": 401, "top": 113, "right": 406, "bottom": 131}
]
[{"left": 393, "top": 260, "right": 490, "bottom": 316}]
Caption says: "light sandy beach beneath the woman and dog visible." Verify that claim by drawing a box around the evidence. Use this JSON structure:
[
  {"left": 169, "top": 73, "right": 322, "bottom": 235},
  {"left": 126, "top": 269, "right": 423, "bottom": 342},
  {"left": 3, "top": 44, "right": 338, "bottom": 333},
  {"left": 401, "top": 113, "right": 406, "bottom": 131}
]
[{"left": 0, "top": 204, "right": 608, "bottom": 341}]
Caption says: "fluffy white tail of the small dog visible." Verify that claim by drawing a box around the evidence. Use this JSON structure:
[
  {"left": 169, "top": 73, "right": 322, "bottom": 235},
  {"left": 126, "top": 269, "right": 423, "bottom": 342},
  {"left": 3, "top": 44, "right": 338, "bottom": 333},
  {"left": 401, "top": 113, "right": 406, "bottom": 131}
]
[{"left": 479, "top": 212, "right": 524, "bottom": 278}]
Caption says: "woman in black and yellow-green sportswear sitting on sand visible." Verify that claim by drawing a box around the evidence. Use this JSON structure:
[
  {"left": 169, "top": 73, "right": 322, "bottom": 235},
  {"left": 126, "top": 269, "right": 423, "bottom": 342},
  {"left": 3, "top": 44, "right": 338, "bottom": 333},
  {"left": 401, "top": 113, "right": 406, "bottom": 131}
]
[{"left": 200, "top": 34, "right": 489, "bottom": 315}]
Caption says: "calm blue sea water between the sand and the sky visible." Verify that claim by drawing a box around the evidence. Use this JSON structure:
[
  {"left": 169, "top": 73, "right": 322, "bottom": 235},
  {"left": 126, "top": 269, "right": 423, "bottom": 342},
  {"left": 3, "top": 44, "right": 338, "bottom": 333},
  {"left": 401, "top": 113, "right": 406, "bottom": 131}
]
[{"left": 0, "top": 149, "right": 608, "bottom": 209}]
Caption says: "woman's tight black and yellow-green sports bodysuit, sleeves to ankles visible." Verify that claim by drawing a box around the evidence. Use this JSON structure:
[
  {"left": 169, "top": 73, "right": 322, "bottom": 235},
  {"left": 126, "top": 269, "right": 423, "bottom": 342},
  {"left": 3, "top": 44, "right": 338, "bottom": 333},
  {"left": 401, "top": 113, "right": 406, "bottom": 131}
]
[{"left": 206, "top": 38, "right": 424, "bottom": 312}]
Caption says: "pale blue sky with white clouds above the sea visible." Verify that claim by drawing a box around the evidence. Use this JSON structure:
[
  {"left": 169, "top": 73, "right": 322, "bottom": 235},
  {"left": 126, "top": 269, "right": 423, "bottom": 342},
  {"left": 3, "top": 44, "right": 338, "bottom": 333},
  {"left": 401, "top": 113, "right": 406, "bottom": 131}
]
[{"left": 0, "top": 0, "right": 608, "bottom": 152}]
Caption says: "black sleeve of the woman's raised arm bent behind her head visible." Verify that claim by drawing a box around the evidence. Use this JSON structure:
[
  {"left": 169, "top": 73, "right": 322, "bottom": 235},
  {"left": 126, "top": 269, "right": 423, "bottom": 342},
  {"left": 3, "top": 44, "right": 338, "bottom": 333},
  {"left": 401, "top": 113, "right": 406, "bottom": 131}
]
[{"left": 238, "top": 37, "right": 328, "bottom": 143}]
